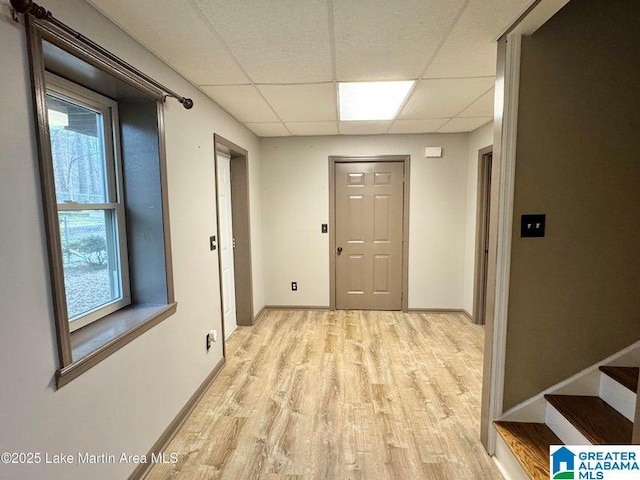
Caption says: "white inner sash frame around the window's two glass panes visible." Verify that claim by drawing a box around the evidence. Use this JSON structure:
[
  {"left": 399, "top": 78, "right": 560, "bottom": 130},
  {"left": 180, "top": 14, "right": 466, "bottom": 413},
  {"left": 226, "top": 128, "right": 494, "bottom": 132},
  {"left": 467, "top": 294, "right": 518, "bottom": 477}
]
[{"left": 45, "top": 72, "right": 131, "bottom": 333}]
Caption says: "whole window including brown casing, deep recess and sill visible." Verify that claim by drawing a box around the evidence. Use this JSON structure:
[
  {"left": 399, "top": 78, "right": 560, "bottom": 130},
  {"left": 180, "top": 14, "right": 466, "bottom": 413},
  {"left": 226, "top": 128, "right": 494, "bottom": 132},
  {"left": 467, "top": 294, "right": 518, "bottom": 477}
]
[{"left": 25, "top": 16, "right": 178, "bottom": 388}]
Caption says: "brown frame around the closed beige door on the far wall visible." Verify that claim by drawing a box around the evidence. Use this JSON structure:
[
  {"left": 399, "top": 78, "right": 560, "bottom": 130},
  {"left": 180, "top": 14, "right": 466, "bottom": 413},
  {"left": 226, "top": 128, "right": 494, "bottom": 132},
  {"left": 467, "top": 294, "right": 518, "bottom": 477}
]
[{"left": 329, "top": 155, "right": 411, "bottom": 312}]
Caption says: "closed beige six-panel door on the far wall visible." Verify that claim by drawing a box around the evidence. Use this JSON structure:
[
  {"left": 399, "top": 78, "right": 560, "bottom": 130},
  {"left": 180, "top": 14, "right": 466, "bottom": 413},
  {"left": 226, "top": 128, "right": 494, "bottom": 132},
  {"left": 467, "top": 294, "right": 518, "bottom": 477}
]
[{"left": 335, "top": 162, "right": 404, "bottom": 310}]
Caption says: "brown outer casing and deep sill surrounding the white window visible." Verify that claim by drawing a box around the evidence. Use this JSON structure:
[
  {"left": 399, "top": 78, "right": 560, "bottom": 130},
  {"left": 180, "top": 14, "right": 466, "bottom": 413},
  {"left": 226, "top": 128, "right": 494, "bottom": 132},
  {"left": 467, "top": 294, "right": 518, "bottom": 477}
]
[{"left": 23, "top": 15, "right": 177, "bottom": 388}]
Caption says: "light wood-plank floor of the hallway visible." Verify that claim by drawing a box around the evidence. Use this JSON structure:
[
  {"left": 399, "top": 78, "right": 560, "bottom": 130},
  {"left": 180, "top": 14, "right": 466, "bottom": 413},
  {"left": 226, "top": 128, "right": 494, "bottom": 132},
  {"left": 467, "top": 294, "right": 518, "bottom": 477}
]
[{"left": 146, "top": 311, "right": 502, "bottom": 480}]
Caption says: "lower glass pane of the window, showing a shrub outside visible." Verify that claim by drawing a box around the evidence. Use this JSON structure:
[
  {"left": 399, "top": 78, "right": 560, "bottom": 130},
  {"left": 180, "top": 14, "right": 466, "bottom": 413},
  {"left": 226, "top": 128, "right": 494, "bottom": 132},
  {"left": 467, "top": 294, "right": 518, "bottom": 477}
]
[{"left": 58, "top": 210, "right": 122, "bottom": 320}]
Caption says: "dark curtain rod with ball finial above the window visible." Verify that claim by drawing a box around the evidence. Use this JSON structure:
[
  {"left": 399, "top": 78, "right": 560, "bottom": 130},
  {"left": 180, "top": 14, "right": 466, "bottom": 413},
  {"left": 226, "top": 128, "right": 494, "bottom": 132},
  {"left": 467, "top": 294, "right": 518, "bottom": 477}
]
[{"left": 11, "top": 0, "right": 193, "bottom": 110}]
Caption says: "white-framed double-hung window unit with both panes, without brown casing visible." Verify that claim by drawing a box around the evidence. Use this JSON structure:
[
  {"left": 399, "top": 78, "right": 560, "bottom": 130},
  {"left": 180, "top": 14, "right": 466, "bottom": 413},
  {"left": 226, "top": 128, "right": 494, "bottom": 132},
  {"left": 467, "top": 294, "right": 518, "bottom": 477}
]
[{"left": 46, "top": 74, "right": 131, "bottom": 331}]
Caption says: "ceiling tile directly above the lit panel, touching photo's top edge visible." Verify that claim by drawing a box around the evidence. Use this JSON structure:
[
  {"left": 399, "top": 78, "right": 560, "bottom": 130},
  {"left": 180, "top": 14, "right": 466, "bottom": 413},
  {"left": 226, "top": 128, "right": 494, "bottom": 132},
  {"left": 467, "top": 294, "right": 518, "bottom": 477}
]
[{"left": 333, "top": 0, "right": 465, "bottom": 81}]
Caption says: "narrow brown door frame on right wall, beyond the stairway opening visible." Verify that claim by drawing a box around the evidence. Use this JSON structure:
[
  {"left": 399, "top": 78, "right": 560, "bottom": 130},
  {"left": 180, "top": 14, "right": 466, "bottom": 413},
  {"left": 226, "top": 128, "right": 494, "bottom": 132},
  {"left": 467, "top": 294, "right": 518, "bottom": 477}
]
[{"left": 472, "top": 145, "right": 493, "bottom": 325}]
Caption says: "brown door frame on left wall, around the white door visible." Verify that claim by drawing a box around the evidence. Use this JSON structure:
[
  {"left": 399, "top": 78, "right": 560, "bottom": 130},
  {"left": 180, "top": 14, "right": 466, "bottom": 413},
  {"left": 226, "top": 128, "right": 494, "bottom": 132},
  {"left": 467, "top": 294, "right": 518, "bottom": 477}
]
[{"left": 213, "top": 133, "right": 254, "bottom": 355}]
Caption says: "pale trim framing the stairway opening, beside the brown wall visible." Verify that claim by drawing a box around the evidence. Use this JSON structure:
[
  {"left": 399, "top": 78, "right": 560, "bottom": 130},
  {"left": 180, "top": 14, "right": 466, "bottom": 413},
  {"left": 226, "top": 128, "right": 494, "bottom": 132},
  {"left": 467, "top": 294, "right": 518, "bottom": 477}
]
[{"left": 480, "top": 0, "right": 569, "bottom": 455}]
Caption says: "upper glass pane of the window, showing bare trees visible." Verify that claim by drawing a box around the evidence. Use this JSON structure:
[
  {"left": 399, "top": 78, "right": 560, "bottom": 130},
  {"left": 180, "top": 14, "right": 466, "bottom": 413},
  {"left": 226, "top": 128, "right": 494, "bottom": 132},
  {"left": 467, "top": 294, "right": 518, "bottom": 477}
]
[{"left": 47, "top": 95, "right": 109, "bottom": 203}]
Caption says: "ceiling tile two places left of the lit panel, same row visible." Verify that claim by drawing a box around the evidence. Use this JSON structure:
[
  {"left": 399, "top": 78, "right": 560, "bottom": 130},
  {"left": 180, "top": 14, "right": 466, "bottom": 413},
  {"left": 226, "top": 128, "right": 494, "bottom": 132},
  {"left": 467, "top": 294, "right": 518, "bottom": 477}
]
[{"left": 200, "top": 85, "right": 278, "bottom": 122}]
